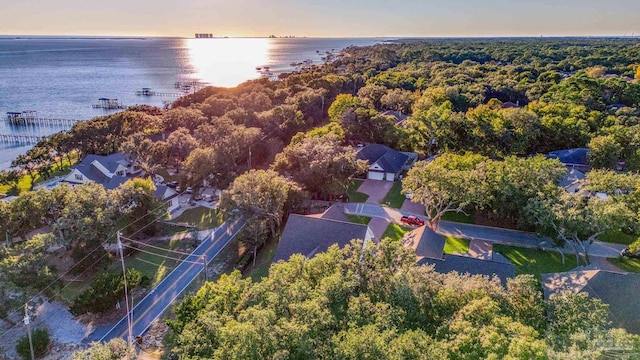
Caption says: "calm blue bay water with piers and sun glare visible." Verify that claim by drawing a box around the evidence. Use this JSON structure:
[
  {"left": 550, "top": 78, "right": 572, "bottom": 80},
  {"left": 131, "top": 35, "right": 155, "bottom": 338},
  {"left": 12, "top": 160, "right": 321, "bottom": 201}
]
[{"left": 0, "top": 37, "right": 382, "bottom": 169}]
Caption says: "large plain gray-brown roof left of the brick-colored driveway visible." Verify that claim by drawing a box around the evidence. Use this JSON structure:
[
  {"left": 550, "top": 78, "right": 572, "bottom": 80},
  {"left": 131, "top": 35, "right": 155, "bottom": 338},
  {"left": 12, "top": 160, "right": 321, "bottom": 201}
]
[{"left": 273, "top": 214, "right": 373, "bottom": 263}]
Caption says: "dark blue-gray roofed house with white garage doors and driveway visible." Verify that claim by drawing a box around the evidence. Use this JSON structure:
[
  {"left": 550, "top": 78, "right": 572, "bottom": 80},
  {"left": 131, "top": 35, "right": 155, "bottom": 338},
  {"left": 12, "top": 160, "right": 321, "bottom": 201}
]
[{"left": 357, "top": 144, "right": 409, "bottom": 181}]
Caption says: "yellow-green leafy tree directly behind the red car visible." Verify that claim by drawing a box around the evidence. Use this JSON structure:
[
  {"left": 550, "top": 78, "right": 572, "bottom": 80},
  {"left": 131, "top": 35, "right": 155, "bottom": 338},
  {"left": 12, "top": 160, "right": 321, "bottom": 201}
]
[{"left": 402, "top": 153, "right": 486, "bottom": 230}]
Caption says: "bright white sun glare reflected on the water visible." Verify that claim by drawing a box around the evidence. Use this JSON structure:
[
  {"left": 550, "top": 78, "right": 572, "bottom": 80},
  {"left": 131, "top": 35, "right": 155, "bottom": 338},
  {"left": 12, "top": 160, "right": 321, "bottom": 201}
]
[{"left": 185, "top": 39, "right": 272, "bottom": 87}]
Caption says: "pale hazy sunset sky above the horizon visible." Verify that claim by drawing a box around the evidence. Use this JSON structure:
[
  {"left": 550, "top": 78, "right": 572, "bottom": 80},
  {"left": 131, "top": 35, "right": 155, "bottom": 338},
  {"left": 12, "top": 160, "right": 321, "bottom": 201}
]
[{"left": 0, "top": 0, "right": 640, "bottom": 37}]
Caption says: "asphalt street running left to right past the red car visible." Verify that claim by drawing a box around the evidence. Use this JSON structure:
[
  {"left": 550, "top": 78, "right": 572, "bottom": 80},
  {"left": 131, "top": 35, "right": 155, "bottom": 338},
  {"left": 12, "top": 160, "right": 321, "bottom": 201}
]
[{"left": 344, "top": 203, "right": 626, "bottom": 257}]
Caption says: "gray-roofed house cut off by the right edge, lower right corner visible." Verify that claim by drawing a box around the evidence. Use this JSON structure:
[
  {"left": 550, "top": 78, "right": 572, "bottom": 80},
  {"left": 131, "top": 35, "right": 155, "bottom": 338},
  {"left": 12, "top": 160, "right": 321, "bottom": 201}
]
[{"left": 542, "top": 269, "right": 640, "bottom": 334}]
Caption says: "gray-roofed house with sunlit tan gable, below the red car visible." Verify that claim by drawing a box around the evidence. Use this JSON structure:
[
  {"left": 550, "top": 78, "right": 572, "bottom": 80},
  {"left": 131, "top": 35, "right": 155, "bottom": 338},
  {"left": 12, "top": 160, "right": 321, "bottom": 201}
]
[{"left": 403, "top": 225, "right": 516, "bottom": 285}]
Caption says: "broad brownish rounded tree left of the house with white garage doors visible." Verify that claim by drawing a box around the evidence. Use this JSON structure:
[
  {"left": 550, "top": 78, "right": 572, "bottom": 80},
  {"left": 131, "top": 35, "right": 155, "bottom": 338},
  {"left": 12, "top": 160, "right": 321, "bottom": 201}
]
[{"left": 271, "top": 135, "right": 367, "bottom": 195}]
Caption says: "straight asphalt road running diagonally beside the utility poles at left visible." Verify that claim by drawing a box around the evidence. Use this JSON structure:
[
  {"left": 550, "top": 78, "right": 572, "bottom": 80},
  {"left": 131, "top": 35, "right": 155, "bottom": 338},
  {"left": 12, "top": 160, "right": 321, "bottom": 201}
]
[{"left": 95, "top": 219, "right": 245, "bottom": 342}]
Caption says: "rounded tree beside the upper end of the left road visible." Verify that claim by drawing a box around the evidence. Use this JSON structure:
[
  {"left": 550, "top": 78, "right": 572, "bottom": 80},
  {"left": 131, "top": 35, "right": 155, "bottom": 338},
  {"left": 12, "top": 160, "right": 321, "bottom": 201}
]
[{"left": 220, "top": 170, "right": 300, "bottom": 266}]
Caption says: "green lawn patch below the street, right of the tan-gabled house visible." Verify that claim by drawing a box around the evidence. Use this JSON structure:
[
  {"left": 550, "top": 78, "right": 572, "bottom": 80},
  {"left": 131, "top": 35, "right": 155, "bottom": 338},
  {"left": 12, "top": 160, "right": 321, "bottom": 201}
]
[{"left": 493, "top": 244, "right": 576, "bottom": 279}]
